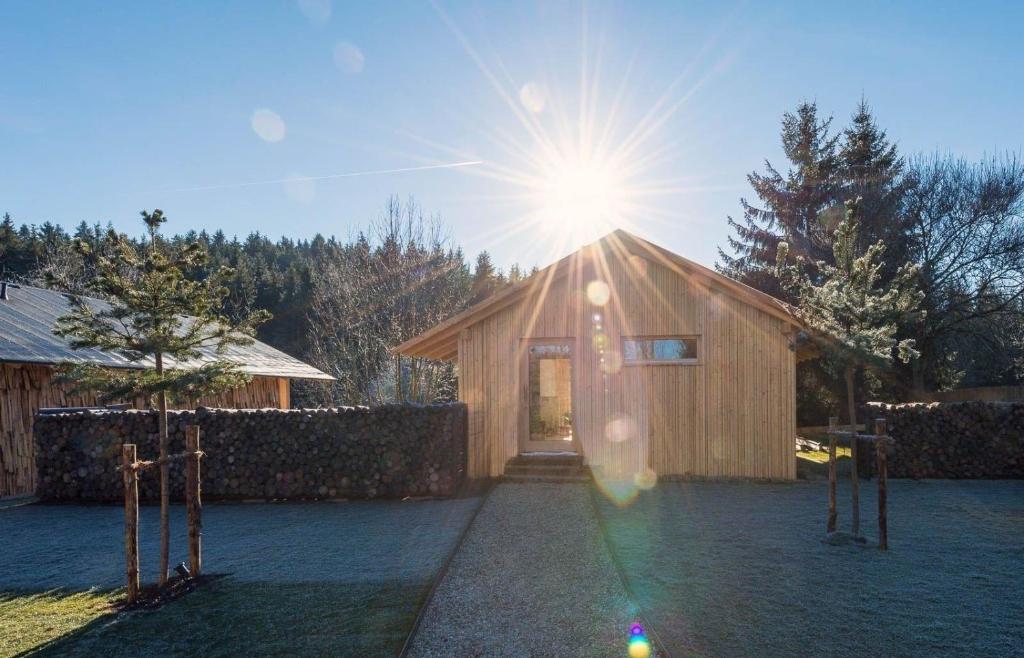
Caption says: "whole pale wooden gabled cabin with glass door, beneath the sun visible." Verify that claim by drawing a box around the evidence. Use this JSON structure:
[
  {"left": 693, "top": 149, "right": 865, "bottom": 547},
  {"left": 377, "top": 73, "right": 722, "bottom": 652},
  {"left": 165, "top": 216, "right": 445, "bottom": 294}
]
[{"left": 395, "top": 230, "right": 800, "bottom": 481}]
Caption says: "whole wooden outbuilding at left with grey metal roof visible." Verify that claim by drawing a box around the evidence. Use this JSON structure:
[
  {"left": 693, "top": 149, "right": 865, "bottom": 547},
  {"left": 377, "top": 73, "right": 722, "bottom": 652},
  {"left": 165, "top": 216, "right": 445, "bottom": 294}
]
[{"left": 0, "top": 284, "right": 334, "bottom": 497}]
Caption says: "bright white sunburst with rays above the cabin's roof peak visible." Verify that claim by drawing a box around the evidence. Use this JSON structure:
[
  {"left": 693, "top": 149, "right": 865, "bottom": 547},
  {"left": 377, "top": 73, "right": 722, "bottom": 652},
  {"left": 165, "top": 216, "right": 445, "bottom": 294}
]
[{"left": 423, "top": 6, "right": 702, "bottom": 262}]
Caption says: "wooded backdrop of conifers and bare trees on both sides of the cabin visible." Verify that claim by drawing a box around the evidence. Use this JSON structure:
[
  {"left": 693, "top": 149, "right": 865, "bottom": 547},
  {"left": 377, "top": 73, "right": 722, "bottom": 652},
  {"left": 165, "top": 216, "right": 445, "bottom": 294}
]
[{"left": 0, "top": 101, "right": 1024, "bottom": 423}]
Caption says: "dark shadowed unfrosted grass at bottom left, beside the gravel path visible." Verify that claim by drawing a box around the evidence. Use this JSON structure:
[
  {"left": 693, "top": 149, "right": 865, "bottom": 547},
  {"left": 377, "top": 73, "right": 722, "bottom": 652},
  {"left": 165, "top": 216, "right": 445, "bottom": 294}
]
[{"left": 14, "top": 577, "right": 429, "bottom": 656}]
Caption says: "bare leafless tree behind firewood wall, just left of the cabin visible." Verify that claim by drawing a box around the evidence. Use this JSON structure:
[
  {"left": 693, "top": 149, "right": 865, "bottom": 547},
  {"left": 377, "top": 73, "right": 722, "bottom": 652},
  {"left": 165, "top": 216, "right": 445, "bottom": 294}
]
[{"left": 309, "top": 198, "right": 469, "bottom": 404}]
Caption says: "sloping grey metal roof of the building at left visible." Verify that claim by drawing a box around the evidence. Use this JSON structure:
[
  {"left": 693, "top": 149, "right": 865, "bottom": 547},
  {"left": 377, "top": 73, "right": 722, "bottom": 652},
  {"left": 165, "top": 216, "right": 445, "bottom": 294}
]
[{"left": 0, "top": 286, "right": 334, "bottom": 380}]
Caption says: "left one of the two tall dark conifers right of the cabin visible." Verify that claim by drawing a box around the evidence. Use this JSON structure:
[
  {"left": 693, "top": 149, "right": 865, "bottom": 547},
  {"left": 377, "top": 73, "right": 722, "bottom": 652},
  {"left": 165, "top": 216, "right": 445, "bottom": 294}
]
[{"left": 719, "top": 102, "right": 841, "bottom": 295}]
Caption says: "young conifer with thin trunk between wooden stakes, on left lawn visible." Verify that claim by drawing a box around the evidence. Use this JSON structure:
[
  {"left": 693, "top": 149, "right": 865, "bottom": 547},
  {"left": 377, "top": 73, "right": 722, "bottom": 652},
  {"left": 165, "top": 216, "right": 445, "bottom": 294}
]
[{"left": 51, "top": 210, "right": 269, "bottom": 584}]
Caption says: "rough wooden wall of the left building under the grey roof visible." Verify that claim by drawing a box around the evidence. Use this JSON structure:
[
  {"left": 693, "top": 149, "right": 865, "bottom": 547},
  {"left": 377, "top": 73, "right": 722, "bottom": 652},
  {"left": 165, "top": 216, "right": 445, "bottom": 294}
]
[{"left": 0, "top": 363, "right": 289, "bottom": 497}]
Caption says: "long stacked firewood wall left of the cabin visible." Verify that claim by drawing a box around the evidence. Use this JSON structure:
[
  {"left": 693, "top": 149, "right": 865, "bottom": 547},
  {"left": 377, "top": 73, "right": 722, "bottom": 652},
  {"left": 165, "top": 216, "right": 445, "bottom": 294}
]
[{"left": 30, "top": 404, "right": 466, "bottom": 502}]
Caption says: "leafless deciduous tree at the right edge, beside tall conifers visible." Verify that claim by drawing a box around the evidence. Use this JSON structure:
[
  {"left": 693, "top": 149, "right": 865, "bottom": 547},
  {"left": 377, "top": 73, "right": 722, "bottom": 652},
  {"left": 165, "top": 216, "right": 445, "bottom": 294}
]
[{"left": 902, "top": 156, "right": 1024, "bottom": 389}]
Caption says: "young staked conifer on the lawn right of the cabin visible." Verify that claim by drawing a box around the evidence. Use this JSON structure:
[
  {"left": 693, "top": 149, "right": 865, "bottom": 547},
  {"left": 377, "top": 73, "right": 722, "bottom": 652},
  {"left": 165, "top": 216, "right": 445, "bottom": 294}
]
[{"left": 776, "top": 200, "right": 924, "bottom": 536}]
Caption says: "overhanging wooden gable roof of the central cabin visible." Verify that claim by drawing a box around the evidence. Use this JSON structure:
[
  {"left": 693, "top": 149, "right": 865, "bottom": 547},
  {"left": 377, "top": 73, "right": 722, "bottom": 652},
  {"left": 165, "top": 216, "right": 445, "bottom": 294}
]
[{"left": 393, "top": 228, "right": 802, "bottom": 360}]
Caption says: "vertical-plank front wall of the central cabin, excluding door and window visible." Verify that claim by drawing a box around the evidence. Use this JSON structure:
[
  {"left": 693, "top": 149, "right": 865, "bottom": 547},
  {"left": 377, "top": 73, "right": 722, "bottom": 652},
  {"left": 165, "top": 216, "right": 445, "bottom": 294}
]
[{"left": 458, "top": 249, "right": 796, "bottom": 479}]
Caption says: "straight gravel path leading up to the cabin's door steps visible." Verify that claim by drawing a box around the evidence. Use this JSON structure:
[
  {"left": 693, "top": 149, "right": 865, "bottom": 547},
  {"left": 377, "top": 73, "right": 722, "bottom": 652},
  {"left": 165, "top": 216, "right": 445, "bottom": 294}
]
[{"left": 401, "top": 484, "right": 637, "bottom": 658}]
